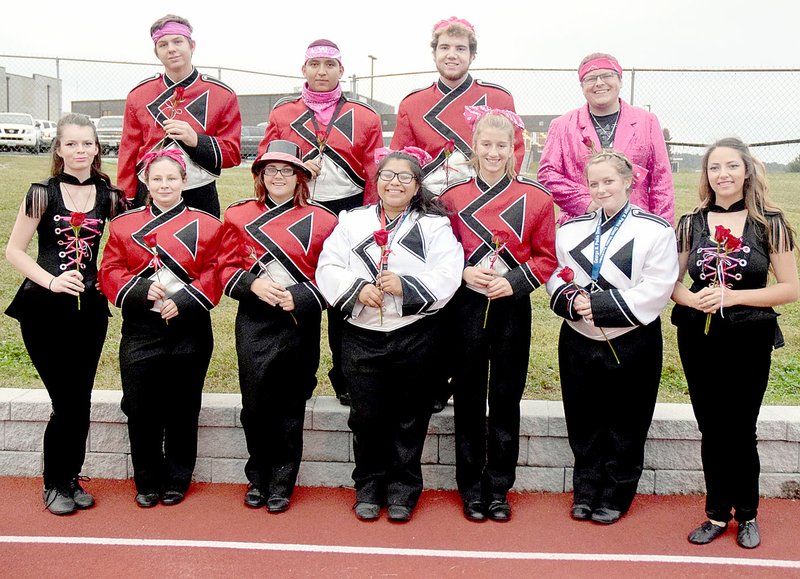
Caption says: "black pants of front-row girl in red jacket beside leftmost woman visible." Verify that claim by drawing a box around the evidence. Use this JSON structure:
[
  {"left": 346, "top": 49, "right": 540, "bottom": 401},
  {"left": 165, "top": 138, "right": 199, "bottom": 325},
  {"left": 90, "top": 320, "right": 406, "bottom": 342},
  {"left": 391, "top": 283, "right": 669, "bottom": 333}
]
[{"left": 120, "top": 312, "right": 214, "bottom": 493}]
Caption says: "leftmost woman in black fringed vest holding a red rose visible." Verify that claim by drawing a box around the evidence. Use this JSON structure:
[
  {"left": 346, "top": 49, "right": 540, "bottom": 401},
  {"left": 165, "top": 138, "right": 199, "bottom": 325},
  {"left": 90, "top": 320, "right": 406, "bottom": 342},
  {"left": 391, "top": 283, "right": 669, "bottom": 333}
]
[{"left": 6, "top": 114, "right": 124, "bottom": 515}]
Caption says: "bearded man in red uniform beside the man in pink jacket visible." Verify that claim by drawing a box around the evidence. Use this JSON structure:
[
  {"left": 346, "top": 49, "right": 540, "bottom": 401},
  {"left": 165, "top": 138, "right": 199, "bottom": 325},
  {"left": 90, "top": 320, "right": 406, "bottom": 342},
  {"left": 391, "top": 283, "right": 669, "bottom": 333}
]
[{"left": 391, "top": 16, "right": 525, "bottom": 195}]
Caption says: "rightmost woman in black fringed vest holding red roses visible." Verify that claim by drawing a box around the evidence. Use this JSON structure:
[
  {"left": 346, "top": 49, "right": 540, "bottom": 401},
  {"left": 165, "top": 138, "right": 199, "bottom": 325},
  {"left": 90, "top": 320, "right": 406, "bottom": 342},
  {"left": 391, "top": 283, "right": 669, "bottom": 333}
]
[{"left": 672, "top": 138, "right": 800, "bottom": 549}]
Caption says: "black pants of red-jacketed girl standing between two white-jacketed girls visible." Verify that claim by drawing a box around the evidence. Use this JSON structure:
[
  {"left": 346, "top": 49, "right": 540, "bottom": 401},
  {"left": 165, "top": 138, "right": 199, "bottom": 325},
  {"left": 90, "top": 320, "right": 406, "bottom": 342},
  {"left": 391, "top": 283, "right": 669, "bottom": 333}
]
[{"left": 453, "top": 286, "right": 531, "bottom": 502}]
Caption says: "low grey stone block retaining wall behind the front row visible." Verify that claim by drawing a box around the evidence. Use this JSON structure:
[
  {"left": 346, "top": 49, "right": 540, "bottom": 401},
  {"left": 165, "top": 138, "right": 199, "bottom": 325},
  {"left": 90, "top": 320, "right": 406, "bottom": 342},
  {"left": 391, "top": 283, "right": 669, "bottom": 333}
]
[{"left": 0, "top": 389, "right": 800, "bottom": 498}]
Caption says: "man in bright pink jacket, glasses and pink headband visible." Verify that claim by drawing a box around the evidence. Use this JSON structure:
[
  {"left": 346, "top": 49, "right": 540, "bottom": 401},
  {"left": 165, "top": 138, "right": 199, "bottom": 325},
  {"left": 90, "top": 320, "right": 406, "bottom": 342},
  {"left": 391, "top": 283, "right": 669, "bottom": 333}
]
[{"left": 538, "top": 53, "right": 675, "bottom": 223}]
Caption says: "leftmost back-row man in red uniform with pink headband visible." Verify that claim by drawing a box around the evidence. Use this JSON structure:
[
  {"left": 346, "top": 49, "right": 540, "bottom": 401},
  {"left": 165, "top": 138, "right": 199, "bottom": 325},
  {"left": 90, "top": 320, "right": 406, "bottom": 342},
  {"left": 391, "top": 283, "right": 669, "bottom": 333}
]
[{"left": 117, "top": 14, "right": 242, "bottom": 217}]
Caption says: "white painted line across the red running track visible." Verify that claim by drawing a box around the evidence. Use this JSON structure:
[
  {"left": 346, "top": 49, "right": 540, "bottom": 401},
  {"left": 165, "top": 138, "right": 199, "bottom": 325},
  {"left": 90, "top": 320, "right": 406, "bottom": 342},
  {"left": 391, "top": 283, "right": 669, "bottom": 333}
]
[{"left": 0, "top": 536, "right": 800, "bottom": 569}]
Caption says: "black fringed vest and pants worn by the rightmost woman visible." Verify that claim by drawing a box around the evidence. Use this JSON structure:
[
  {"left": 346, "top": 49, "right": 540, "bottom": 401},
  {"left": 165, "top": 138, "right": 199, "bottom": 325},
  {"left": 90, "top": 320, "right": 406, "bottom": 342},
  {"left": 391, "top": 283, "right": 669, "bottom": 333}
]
[{"left": 672, "top": 206, "right": 794, "bottom": 523}]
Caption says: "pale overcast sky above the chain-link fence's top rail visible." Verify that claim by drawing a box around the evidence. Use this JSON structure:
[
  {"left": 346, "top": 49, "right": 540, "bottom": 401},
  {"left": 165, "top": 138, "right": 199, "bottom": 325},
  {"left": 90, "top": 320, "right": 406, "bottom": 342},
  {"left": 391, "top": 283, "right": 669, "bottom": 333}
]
[{"left": 0, "top": 0, "right": 800, "bottom": 76}]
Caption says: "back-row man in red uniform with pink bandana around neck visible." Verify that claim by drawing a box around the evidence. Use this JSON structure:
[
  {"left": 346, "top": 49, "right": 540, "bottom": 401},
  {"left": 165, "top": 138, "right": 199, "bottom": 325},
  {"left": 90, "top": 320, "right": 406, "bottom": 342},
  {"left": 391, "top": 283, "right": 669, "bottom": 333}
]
[{"left": 258, "top": 39, "right": 383, "bottom": 404}]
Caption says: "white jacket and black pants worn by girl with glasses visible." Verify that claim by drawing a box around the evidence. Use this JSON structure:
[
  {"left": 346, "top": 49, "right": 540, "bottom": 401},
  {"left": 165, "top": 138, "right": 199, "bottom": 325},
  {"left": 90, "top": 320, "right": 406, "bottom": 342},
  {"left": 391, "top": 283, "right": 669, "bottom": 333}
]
[{"left": 317, "top": 204, "right": 463, "bottom": 508}]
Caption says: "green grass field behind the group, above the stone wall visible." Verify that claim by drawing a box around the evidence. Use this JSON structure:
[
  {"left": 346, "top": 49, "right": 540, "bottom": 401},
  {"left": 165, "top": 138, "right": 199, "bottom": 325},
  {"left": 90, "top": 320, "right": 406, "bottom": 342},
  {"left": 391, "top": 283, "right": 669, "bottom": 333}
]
[{"left": 0, "top": 155, "right": 800, "bottom": 405}]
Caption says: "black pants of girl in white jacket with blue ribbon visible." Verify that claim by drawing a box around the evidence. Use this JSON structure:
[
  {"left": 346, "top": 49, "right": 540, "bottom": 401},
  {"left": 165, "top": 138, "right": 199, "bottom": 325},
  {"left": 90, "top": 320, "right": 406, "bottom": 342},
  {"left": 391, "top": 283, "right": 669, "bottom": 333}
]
[{"left": 558, "top": 319, "right": 663, "bottom": 512}]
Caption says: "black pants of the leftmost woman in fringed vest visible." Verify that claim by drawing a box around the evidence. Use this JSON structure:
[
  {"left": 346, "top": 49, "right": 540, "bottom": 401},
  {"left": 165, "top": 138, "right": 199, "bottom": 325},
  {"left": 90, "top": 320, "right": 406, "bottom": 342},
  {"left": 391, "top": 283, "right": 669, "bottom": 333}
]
[{"left": 20, "top": 290, "right": 108, "bottom": 487}]
